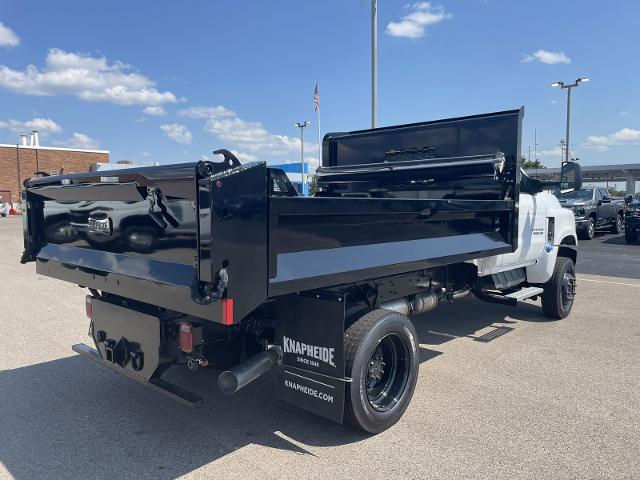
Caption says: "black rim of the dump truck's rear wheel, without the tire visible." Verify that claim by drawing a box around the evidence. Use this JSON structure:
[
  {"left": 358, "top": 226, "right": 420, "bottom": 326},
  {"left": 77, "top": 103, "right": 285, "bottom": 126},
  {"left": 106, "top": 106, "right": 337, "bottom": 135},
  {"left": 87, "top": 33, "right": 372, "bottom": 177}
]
[{"left": 366, "top": 334, "right": 410, "bottom": 412}]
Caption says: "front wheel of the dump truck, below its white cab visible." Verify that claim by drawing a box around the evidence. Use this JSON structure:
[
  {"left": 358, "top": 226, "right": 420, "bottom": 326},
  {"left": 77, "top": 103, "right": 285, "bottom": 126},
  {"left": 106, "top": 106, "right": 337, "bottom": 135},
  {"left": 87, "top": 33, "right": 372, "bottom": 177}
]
[{"left": 542, "top": 257, "right": 576, "bottom": 320}]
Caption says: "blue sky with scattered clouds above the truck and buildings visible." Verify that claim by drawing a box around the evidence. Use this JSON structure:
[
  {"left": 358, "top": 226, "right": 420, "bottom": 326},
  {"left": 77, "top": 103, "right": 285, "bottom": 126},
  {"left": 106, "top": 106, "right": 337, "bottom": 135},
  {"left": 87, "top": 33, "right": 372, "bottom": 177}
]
[{"left": 0, "top": 0, "right": 640, "bottom": 171}]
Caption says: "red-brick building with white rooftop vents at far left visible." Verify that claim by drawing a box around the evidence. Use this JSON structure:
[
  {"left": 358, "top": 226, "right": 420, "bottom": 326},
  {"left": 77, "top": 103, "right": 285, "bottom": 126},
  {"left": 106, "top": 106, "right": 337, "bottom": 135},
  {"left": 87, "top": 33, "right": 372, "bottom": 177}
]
[{"left": 0, "top": 131, "right": 109, "bottom": 203}]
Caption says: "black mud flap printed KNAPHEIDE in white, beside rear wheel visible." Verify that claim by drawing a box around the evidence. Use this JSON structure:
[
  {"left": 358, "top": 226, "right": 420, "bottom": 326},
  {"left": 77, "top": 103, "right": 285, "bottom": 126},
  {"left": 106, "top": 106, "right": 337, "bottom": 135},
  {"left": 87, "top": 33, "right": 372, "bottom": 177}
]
[{"left": 276, "top": 293, "right": 346, "bottom": 423}]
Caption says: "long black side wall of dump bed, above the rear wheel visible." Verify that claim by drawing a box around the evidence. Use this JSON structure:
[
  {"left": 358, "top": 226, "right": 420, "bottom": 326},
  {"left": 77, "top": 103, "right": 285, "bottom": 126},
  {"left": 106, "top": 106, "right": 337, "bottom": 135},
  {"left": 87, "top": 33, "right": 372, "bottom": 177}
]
[{"left": 269, "top": 197, "right": 514, "bottom": 297}]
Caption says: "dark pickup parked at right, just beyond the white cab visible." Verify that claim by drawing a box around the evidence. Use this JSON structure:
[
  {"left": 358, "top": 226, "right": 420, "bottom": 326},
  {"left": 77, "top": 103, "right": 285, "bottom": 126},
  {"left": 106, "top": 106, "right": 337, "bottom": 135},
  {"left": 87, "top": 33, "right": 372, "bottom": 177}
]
[{"left": 556, "top": 187, "right": 625, "bottom": 240}]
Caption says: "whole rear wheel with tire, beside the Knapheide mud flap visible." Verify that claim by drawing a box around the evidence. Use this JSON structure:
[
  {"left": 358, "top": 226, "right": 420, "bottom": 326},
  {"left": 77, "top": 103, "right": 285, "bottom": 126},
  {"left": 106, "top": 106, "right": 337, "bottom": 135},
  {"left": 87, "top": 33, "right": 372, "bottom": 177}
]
[{"left": 344, "top": 309, "right": 419, "bottom": 433}]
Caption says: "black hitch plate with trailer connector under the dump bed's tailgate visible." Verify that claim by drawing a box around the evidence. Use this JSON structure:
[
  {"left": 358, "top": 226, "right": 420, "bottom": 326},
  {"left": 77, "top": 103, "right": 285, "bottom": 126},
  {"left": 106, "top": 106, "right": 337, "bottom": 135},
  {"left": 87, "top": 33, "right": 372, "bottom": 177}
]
[{"left": 92, "top": 299, "right": 160, "bottom": 380}]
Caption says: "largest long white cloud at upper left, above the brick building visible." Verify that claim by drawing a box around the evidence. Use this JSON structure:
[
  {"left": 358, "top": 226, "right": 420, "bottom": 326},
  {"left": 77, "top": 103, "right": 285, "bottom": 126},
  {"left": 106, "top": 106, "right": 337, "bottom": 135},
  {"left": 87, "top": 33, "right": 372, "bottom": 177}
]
[{"left": 0, "top": 48, "right": 178, "bottom": 105}]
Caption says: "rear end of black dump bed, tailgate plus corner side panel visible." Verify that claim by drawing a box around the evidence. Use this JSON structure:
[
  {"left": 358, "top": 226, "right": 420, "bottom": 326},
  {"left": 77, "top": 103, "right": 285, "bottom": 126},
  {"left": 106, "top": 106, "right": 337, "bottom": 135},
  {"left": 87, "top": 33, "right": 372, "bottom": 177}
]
[{"left": 22, "top": 159, "right": 267, "bottom": 324}]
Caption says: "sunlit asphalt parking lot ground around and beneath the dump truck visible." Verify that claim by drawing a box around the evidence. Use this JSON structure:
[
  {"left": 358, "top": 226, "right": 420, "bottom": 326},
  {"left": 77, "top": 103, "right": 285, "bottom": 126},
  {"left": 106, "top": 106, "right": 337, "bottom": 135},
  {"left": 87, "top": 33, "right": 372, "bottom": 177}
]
[{"left": 0, "top": 218, "right": 640, "bottom": 480}]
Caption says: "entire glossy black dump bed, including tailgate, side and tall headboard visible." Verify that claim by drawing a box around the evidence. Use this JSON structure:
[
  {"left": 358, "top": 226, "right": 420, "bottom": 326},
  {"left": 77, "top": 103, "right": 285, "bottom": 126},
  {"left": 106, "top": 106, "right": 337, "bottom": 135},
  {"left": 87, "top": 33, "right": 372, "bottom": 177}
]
[{"left": 23, "top": 110, "right": 522, "bottom": 323}]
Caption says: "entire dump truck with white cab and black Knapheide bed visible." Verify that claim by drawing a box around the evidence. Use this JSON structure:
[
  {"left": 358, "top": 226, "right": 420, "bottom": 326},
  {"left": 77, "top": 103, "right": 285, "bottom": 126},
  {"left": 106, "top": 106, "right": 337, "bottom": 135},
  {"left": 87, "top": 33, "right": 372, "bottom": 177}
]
[{"left": 22, "top": 110, "right": 581, "bottom": 433}]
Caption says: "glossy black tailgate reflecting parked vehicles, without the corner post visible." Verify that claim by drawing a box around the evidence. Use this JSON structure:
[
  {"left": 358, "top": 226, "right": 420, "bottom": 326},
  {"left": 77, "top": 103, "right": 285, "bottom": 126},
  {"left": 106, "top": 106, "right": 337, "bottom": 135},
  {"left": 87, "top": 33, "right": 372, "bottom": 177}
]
[{"left": 23, "top": 164, "right": 215, "bottom": 318}]
